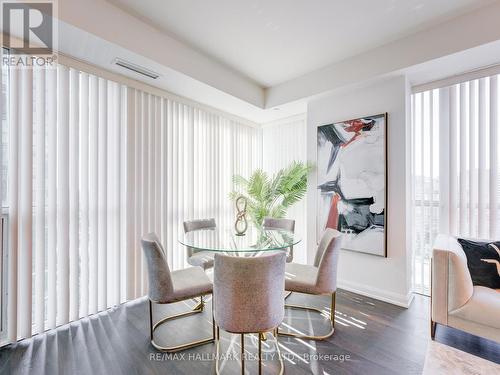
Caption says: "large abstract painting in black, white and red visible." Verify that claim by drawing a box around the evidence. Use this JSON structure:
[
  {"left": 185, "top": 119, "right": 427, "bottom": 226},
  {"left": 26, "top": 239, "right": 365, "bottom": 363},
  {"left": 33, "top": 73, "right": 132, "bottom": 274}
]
[{"left": 317, "top": 114, "right": 387, "bottom": 256}]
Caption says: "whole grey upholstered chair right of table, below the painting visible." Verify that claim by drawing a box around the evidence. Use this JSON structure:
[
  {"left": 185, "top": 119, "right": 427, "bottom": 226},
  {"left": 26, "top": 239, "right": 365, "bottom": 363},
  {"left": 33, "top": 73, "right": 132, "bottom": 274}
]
[{"left": 278, "top": 228, "right": 342, "bottom": 340}]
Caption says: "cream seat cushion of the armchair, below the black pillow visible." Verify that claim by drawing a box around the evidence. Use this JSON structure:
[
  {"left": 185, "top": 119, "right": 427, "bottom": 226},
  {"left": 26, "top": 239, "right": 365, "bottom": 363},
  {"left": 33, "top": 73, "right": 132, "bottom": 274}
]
[{"left": 450, "top": 286, "right": 500, "bottom": 329}]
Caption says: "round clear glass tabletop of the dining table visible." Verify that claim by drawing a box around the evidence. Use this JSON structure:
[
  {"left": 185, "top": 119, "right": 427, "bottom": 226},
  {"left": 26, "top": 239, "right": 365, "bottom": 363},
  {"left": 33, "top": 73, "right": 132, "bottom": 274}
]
[{"left": 179, "top": 227, "right": 300, "bottom": 253}]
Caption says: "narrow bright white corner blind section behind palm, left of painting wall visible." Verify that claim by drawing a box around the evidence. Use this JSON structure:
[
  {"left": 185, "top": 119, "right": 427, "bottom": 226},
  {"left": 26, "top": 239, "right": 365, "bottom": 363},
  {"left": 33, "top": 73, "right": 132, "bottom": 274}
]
[{"left": 262, "top": 115, "right": 307, "bottom": 263}]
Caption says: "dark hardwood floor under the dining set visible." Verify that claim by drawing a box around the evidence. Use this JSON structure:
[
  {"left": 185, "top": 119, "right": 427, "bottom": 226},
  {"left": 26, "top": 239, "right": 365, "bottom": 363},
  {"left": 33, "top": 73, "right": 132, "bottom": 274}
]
[{"left": 0, "top": 290, "right": 500, "bottom": 375}]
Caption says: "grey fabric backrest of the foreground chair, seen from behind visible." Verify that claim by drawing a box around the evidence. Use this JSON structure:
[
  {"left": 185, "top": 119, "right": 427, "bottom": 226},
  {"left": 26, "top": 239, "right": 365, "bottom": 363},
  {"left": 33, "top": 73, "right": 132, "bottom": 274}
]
[{"left": 213, "top": 252, "right": 285, "bottom": 333}]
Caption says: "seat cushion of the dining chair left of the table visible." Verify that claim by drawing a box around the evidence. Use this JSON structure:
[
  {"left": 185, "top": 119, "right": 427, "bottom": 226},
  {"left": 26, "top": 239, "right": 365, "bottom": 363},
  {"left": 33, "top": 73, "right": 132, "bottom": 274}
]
[{"left": 167, "top": 267, "right": 212, "bottom": 302}]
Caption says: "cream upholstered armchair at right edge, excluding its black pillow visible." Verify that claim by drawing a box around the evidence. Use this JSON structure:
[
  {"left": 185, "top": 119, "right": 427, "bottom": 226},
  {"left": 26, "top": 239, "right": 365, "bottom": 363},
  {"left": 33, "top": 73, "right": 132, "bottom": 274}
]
[{"left": 431, "top": 235, "right": 500, "bottom": 342}]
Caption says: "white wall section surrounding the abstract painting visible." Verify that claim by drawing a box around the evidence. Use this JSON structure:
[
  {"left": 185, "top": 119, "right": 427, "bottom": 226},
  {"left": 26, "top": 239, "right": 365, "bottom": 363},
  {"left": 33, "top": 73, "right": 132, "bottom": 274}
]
[{"left": 307, "top": 76, "right": 411, "bottom": 306}]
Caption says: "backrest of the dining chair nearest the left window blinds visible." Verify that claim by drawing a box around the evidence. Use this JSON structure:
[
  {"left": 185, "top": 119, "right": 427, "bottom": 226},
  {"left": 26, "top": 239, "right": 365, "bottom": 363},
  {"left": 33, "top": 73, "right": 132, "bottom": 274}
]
[{"left": 141, "top": 233, "right": 174, "bottom": 302}]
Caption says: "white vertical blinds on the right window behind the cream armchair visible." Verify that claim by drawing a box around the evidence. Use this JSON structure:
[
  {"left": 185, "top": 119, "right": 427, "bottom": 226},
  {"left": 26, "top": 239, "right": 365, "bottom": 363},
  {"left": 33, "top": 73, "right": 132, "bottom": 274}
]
[{"left": 412, "top": 75, "right": 500, "bottom": 293}]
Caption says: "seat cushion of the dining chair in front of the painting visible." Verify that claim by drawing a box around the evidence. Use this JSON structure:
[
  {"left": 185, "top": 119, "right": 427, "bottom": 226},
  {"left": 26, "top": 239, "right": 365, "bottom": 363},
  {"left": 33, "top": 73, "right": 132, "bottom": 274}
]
[{"left": 285, "top": 263, "right": 326, "bottom": 294}]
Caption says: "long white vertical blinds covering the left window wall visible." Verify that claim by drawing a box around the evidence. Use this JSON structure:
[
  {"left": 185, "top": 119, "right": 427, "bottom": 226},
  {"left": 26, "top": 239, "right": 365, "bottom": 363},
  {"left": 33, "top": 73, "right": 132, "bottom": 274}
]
[{"left": 1, "top": 65, "right": 261, "bottom": 342}]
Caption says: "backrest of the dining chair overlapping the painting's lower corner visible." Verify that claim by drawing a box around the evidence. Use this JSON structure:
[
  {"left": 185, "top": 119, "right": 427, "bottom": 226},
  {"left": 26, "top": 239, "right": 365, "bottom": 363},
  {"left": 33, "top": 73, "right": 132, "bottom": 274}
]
[{"left": 314, "top": 228, "right": 342, "bottom": 293}]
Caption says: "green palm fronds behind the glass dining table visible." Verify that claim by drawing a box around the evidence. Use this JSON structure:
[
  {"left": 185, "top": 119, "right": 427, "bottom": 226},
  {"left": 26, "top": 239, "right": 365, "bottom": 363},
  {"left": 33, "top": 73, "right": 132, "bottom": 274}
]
[{"left": 230, "top": 161, "right": 312, "bottom": 227}]
